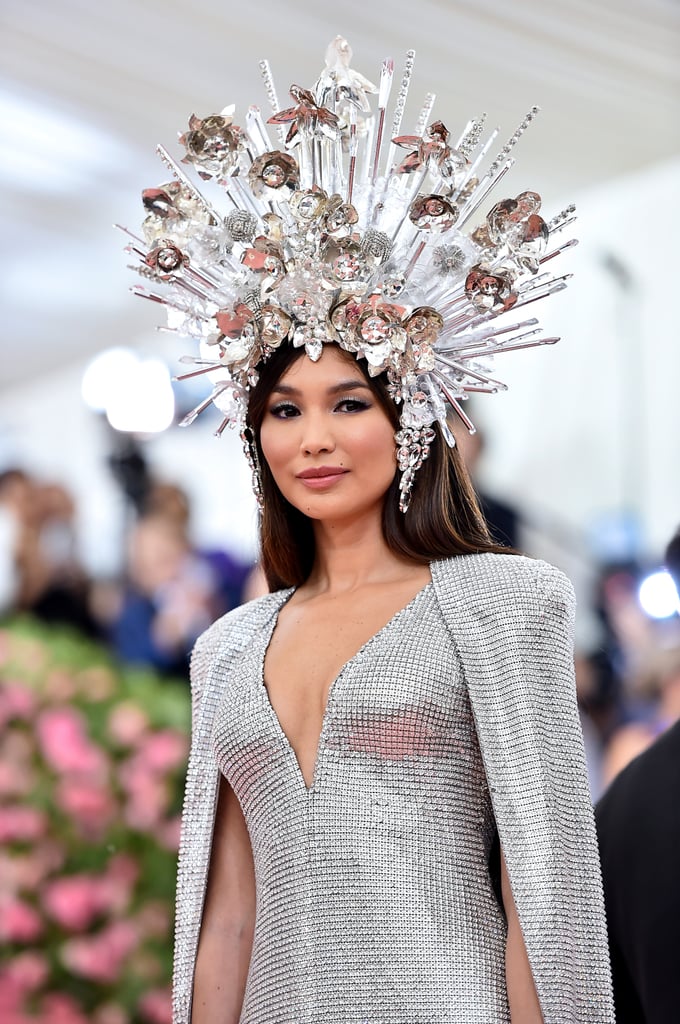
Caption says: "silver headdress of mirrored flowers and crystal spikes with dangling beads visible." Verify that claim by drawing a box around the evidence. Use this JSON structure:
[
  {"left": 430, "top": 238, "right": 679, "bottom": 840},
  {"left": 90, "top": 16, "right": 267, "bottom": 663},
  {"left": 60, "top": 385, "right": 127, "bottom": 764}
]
[{"left": 124, "top": 37, "right": 573, "bottom": 512}]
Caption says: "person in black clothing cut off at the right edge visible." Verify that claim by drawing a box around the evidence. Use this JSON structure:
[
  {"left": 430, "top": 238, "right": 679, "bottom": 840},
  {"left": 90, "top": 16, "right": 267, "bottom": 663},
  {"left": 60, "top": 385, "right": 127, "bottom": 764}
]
[{"left": 595, "top": 529, "right": 680, "bottom": 1024}]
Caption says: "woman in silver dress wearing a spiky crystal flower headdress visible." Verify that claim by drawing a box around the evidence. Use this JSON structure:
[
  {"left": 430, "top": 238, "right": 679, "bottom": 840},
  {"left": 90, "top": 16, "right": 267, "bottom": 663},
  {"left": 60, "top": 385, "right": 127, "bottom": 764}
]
[{"left": 120, "top": 40, "right": 612, "bottom": 1024}]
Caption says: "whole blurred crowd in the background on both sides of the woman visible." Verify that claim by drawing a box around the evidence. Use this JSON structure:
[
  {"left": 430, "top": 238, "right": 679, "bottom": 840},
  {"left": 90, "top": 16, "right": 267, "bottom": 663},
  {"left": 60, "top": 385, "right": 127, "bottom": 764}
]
[{"left": 0, "top": 456, "right": 680, "bottom": 798}]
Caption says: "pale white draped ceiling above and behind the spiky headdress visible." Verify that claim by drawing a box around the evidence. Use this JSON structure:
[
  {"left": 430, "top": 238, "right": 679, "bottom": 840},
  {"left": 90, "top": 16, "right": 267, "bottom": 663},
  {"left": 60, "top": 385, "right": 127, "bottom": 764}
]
[{"left": 0, "top": 0, "right": 680, "bottom": 387}]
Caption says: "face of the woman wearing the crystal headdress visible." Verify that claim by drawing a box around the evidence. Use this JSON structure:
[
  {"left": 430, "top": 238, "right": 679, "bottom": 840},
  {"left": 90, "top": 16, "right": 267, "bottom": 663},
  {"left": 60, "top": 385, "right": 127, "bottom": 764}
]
[{"left": 260, "top": 345, "right": 396, "bottom": 521}]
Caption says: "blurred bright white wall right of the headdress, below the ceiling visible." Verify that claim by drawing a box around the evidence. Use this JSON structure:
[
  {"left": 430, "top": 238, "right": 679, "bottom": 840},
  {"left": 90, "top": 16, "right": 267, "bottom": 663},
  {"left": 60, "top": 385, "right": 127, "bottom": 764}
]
[{"left": 476, "top": 155, "right": 680, "bottom": 557}]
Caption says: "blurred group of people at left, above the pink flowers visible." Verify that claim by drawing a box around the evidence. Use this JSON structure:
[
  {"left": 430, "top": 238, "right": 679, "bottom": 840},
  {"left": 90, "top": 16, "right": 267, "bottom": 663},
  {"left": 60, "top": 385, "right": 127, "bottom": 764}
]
[{"left": 0, "top": 468, "right": 260, "bottom": 678}]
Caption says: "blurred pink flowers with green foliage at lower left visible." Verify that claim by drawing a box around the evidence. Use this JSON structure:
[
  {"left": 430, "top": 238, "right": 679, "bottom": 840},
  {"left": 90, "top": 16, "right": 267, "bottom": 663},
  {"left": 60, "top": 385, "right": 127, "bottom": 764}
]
[{"left": 0, "top": 622, "right": 189, "bottom": 1024}]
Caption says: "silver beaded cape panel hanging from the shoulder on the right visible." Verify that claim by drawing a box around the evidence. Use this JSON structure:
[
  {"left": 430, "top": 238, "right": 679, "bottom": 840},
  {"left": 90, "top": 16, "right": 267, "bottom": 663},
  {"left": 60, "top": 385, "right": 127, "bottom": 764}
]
[{"left": 432, "top": 555, "right": 614, "bottom": 1024}]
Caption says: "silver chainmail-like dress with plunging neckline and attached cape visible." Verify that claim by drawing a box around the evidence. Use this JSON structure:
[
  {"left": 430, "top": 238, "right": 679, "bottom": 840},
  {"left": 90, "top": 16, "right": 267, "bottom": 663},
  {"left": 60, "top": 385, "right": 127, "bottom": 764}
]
[{"left": 174, "top": 555, "right": 613, "bottom": 1024}]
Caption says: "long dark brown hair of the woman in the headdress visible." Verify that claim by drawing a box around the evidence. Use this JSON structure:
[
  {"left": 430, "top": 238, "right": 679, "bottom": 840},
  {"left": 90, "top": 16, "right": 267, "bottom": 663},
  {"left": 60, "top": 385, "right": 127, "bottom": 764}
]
[{"left": 248, "top": 345, "right": 508, "bottom": 590}]
